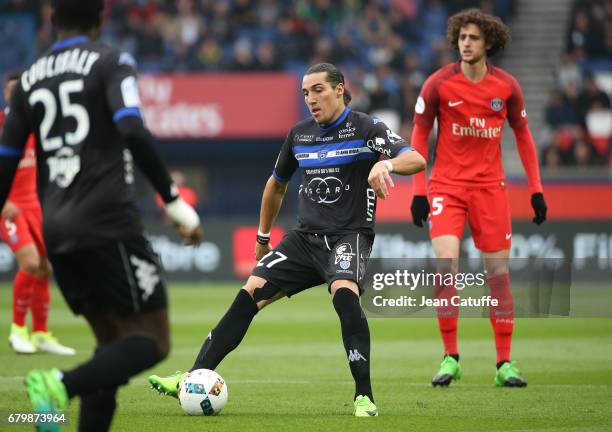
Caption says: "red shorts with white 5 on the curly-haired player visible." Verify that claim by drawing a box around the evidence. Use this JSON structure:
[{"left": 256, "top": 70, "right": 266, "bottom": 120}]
[{"left": 429, "top": 183, "right": 512, "bottom": 252}]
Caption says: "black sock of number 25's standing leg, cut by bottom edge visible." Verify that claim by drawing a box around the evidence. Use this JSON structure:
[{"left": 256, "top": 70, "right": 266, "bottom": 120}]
[{"left": 79, "top": 388, "right": 117, "bottom": 432}]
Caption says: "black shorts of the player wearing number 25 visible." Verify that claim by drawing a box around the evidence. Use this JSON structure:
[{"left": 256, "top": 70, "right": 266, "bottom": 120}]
[{"left": 49, "top": 236, "right": 168, "bottom": 315}]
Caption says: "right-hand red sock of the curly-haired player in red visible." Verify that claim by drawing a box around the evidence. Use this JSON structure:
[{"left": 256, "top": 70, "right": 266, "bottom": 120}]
[{"left": 488, "top": 273, "right": 514, "bottom": 363}]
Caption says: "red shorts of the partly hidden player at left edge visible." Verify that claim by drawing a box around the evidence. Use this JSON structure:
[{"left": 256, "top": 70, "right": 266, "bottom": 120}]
[{"left": 0, "top": 209, "right": 47, "bottom": 256}]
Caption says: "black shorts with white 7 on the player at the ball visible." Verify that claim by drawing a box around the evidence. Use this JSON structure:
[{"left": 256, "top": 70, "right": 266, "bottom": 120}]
[{"left": 252, "top": 231, "right": 374, "bottom": 297}]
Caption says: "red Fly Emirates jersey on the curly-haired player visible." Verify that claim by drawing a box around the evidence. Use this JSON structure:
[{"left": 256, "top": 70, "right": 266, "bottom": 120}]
[{"left": 414, "top": 62, "right": 527, "bottom": 187}]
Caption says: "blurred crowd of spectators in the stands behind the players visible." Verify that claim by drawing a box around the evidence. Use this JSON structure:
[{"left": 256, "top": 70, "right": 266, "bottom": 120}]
[{"left": 0, "top": 0, "right": 612, "bottom": 169}]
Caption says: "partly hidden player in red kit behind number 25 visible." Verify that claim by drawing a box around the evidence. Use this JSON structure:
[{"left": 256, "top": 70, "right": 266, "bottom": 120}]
[{"left": 0, "top": 73, "right": 75, "bottom": 355}]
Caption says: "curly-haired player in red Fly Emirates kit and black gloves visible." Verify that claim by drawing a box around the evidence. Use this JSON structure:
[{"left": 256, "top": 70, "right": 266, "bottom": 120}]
[{"left": 411, "top": 9, "right": 546, "bottom": 387}]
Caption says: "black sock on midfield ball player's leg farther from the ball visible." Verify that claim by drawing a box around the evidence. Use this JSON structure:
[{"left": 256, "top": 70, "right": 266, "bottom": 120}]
[{"left": 333, "top": 288, "right": 374, "bottom": 402}]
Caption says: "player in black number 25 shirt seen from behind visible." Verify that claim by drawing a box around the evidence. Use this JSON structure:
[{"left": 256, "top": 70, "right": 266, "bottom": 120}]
[{"left": 0, "top": 0, "right": 201, "bottom": 431}]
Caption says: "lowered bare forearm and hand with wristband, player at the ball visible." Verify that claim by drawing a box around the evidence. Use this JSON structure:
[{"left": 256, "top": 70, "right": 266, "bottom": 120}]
[{"left": 255, "top": 176, "right": 287, "bottom": 261}]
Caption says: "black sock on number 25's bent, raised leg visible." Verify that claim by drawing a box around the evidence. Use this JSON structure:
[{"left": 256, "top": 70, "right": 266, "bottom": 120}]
[{"left": 63, "top": 335, "right": 162, "bottom": 397}]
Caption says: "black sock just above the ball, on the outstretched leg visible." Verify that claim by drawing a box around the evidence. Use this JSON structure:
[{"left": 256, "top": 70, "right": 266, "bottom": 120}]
[{"left": 191, "top": 289, "right": 259, "bottom": 370}]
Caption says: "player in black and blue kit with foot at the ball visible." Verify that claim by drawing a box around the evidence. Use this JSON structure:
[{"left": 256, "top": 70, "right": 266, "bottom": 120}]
[{"left": 149, "top": 63, "right": 425, "bottom": 417}]
